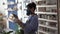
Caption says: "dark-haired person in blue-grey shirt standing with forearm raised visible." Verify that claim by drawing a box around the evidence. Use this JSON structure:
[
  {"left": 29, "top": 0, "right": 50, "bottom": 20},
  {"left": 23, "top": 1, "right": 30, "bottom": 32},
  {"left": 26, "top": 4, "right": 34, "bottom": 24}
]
[{"left": 17, "top": 2, "right": 38, "bottom": 34}]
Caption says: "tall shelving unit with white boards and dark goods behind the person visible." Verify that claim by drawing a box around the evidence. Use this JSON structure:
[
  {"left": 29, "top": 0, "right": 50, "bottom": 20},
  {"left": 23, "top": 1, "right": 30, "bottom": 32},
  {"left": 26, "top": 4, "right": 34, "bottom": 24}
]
[{"left": 35, "top": 0, "right": 58, "bottom": 34}]
